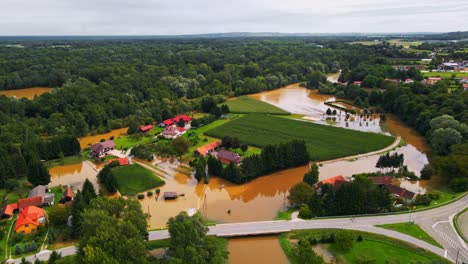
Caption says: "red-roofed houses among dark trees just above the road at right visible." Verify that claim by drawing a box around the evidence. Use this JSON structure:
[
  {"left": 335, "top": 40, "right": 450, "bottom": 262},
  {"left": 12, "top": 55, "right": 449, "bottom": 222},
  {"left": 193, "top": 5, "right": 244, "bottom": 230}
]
[{"left": 315, "top": 175, "right": 417, "bottom": 204}]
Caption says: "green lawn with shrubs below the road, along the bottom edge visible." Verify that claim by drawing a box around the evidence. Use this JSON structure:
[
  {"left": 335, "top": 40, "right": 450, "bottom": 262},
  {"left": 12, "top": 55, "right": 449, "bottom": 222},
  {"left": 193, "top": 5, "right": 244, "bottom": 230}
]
[{"left": 280, "top": 229, "right": 449, "bottom": 264}]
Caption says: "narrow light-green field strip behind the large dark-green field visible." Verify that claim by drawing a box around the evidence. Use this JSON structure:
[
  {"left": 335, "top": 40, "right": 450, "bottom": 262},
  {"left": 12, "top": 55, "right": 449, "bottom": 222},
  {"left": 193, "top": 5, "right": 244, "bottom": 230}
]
[{"left": 225, "top": 96, "right": 289, "bottom": 115}]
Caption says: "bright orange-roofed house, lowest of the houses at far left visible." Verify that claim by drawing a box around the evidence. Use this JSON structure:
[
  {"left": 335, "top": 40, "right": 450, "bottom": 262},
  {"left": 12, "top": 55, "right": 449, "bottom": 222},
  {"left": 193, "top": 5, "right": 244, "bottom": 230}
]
[{"left": 14, "top": 206, "right": 45, "bottom": 234}]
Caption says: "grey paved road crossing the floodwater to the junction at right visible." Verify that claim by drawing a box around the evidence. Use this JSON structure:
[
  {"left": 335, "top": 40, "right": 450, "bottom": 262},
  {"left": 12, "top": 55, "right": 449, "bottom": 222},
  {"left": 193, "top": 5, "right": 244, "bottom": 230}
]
[{"left": 12, "top": 195, "right": 468, "bottom": 263}]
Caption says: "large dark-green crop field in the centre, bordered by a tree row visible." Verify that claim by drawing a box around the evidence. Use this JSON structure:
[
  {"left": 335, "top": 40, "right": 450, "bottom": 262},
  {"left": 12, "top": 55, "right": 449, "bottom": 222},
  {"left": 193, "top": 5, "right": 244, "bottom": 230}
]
[{"left": 205, "top": 114, "right": 394, "bottom": 160}]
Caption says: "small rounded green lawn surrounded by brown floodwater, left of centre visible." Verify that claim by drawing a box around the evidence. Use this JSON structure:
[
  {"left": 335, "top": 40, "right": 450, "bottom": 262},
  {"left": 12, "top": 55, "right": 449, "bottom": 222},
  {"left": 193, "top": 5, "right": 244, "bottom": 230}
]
[{"left": 112, "top": 164, "right": 165, "bottom": 195}]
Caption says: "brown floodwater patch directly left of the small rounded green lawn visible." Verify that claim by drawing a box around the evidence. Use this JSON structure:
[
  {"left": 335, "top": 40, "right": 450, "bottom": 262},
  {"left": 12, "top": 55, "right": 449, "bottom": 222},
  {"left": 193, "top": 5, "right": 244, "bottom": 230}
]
[{"left": 49, "top": 161, "right": 99, "bottom": 190}]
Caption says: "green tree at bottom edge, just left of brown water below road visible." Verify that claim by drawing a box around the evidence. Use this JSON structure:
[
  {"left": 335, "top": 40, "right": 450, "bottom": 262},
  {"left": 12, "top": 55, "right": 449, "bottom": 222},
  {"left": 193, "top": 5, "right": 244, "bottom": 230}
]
[{"left": 167, "top": 212, "right": 228, "bottom": 264}]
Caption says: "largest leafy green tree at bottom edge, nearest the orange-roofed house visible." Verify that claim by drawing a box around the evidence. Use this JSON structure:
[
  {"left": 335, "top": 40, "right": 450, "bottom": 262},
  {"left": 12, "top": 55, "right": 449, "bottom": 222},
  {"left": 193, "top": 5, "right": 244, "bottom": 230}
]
[{"left": 78, "top": 197, "right": 148, "bottom": 263}]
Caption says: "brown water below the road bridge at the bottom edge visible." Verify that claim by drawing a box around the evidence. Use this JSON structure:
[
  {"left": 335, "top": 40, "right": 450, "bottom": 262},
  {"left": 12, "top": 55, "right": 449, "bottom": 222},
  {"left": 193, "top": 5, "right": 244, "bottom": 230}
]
[{"left": 228, "top": 236, "right": 289, "bottom": 264}]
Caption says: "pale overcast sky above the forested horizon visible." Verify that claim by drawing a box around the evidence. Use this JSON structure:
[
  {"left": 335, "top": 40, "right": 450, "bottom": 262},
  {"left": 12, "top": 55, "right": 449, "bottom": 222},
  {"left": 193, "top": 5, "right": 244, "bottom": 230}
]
[{"left": 0, "top": 0, "right": 468, "bottom": 35}]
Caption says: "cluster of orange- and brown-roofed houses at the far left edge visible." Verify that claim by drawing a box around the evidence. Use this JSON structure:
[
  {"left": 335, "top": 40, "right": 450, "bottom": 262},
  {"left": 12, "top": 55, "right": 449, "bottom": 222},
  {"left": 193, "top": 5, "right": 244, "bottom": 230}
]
[{"left": 1, "top": 185, "right": 73, "bottom": 234}]
